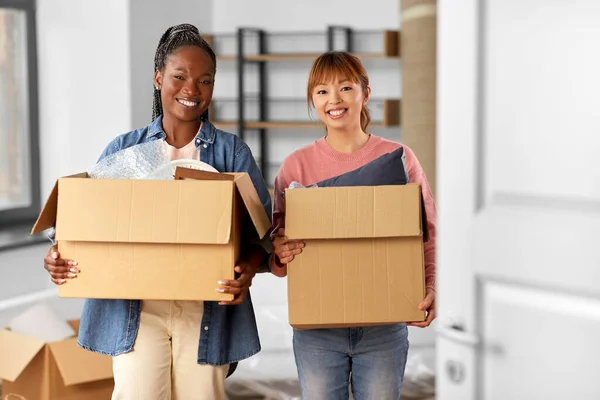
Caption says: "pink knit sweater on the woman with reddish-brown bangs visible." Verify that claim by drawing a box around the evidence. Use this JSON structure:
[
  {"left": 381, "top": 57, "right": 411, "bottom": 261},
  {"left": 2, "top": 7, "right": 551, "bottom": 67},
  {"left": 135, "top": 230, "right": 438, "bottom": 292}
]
[{"left": 271, "top": 135, "right": 436, "bottom": 290}]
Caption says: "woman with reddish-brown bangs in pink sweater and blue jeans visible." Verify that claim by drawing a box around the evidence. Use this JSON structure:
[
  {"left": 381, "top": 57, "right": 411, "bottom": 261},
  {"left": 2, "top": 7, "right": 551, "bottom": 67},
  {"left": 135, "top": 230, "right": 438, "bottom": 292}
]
[{"left": 271, "top": 52, "right": 436, "bottom": 400}]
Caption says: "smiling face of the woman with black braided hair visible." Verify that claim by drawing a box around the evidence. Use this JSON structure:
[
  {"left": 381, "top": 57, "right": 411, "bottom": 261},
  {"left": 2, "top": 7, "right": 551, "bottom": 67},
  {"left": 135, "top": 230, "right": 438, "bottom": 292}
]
[{"left": 154, "top": 46, "right": 215, "bottom": 122}]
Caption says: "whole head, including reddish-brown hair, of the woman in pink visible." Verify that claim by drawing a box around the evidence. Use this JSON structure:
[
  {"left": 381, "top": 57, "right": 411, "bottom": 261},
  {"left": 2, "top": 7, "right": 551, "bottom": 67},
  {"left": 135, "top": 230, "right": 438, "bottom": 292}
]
[{"left": 307, "top": 51, "right": 371, "bottom": 132}]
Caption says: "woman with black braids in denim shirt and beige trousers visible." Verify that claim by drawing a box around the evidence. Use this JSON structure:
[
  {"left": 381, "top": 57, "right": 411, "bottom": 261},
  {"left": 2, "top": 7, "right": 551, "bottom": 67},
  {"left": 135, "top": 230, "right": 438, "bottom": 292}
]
[{"left": 39, "top": 24, "right": 271, "bottom": 400}]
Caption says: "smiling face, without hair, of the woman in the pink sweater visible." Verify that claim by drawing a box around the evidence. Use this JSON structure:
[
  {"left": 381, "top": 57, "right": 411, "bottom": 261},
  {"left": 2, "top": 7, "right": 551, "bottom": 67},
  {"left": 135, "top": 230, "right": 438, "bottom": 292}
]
[{"left": 312, "top": 77, "right": 369, "bottom": 131}]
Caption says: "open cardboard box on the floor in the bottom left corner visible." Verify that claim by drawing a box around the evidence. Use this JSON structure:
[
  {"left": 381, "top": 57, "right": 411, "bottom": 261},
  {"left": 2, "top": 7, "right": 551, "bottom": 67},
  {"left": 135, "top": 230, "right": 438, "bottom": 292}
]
[{"left": 0, "top": 321, "right": 114, "bottom": 400}]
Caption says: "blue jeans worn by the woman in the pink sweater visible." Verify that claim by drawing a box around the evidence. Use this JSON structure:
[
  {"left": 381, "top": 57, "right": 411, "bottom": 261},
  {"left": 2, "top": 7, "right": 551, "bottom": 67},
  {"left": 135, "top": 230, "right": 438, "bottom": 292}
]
[{"left": 294, "top": 324, "right": 408, "bottom": 400}]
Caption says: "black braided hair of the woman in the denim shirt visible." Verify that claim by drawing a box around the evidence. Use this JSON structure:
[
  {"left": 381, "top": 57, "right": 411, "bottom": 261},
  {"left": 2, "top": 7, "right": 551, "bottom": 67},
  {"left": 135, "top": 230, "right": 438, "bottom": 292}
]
[{"left": 152, "top": 24, "right": 217, "bottom": 121}]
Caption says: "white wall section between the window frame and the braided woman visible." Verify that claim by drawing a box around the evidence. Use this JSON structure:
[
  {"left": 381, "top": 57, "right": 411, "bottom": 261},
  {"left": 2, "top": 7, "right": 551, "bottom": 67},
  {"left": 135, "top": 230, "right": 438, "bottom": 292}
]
[{"left": 37, "top": 0, "right": 131, "bottom": 201}]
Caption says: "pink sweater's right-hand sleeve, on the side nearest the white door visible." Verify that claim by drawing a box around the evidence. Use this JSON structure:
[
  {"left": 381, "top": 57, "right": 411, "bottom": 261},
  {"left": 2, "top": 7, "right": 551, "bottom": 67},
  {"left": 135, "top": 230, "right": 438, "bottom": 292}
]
[{"left": 404, "top": 146, "right": 437, "bottom": 291}]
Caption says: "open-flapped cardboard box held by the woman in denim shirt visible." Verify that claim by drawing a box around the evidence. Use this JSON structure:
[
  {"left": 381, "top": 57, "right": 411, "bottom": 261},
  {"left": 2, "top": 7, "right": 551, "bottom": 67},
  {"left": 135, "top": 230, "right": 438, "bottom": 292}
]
[{"left": 32, "top": 167, "right": 271, "bottom": 301}]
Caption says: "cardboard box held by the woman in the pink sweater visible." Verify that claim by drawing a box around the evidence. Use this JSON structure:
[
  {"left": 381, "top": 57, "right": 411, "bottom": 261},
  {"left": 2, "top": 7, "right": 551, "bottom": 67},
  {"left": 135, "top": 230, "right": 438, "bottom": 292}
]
[{"left": 285, "top": 184, "right": 425, "bottom": 328}]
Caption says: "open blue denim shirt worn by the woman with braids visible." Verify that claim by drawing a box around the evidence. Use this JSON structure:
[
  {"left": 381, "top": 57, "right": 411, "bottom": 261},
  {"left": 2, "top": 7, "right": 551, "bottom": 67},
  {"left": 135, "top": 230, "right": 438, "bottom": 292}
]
[{"left": 78, "top": 117, "right": 271, "bottom": 365}]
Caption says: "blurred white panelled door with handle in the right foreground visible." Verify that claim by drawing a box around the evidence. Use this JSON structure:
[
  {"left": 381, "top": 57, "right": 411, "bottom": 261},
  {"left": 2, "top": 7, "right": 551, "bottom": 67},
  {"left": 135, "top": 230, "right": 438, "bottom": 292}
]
[{"left": 437, "top": 0, "right": 600, "bottom": 400}]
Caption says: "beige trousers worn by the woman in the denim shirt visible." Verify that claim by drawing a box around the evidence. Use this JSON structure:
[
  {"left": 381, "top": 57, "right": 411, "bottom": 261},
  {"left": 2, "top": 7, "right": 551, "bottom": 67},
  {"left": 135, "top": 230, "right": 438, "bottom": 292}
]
[{"left": 112, "top": 300, "right": 229, "bottom": 400}]
